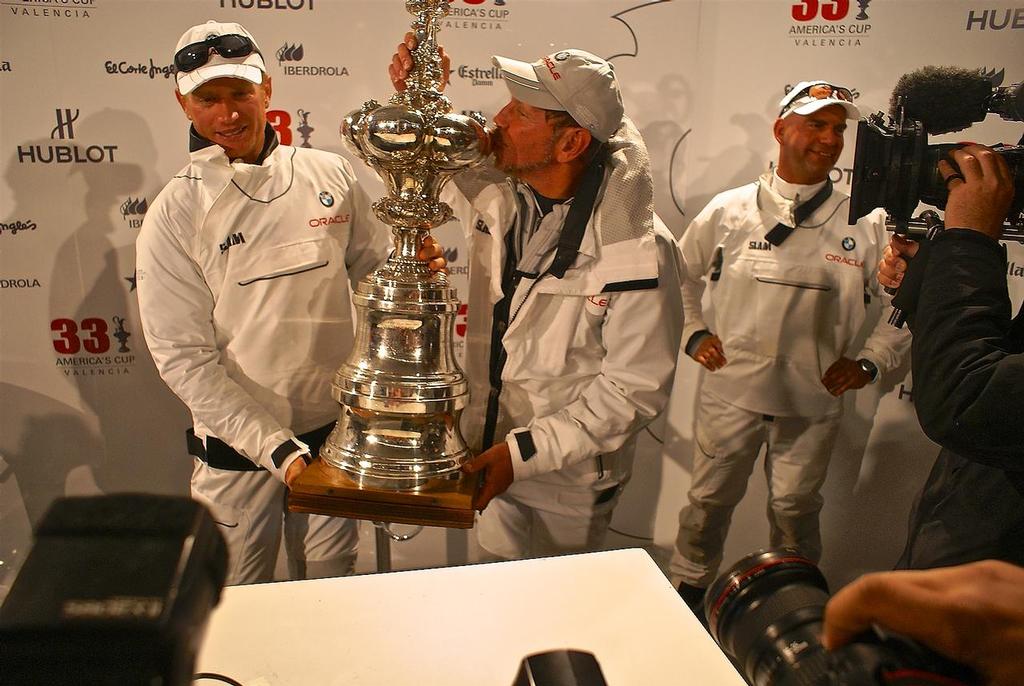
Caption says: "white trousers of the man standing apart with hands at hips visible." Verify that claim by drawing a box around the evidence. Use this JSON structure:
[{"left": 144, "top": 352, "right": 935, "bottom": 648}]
[{"left": 669, "top": 392, "right": 842, "bottom": 588}]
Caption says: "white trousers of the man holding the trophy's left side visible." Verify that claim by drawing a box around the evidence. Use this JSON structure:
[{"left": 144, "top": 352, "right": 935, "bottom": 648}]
[{"left": 191, "top": 460, "right": 358, "bottom": 586}]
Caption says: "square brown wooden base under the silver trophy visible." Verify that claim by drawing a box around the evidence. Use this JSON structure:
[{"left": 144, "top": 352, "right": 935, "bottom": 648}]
[{"left": 288, "top": 458, "right": 479, "bottom": 528}]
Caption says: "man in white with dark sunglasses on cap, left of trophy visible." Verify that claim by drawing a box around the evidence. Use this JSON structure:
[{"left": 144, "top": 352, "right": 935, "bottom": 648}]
[{"left": 136, "top": 22, "right": 443, "bottom": 584}]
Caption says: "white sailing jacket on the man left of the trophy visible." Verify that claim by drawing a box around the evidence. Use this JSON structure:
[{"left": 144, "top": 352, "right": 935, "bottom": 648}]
[{"left": 136, "top": 145, "right": 390, "bottom": 476}]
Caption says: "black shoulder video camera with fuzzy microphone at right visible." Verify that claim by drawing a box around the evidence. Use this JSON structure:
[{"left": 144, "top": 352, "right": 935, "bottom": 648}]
[{"left": 850, "top": 67, "right": 1024, "bottom": 240}]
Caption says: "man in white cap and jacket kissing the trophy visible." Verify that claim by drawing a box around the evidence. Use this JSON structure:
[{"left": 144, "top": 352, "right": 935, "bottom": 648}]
[{"left": 390, "top": 35, "right": 681, "bottom": 558}]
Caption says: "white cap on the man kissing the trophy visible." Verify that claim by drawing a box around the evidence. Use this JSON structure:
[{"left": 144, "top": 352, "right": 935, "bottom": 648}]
[{"left": 492, "top": 50, "right": 623, "bottom": 142}]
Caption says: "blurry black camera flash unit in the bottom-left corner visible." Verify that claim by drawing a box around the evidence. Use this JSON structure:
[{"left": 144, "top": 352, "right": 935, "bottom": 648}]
[{"left": 0, "top": 495, "right": 227, "bottom": 686}]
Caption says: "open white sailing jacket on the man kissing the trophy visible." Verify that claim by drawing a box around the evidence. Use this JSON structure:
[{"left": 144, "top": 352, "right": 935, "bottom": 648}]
[{"left": 444, "top": 172, "right": 682, "bottom": 489}]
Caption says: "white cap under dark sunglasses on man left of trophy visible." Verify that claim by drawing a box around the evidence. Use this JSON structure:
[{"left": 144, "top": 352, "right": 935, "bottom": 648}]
[{"left": 174, "top": 19, "right": 266, "bottom": 95}]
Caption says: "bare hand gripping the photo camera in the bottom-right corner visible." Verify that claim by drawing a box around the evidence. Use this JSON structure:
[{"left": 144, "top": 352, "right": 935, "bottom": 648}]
[{"left": 822, "top": 560, "right": 1024, "bottom": 686}]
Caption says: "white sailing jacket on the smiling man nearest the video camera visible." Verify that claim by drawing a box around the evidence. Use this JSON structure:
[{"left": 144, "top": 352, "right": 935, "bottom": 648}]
[{"left": 680, "top": 172, "right": 910, "bottom": 417}]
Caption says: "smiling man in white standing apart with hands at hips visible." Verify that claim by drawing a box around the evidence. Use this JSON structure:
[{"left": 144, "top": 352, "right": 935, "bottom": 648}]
[{"left": 670, "top": 81, "right": 909, "bottom": 614}]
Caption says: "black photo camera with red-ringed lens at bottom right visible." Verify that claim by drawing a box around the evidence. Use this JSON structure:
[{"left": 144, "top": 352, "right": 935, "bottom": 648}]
[{"left": 705, "top": 549, "right": 981, "bottom": 686}]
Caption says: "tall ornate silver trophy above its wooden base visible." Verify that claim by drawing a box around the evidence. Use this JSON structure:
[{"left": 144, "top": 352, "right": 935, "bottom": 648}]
[{"left": 321, "top": 0, "right": 487, "bottom": 490}]
